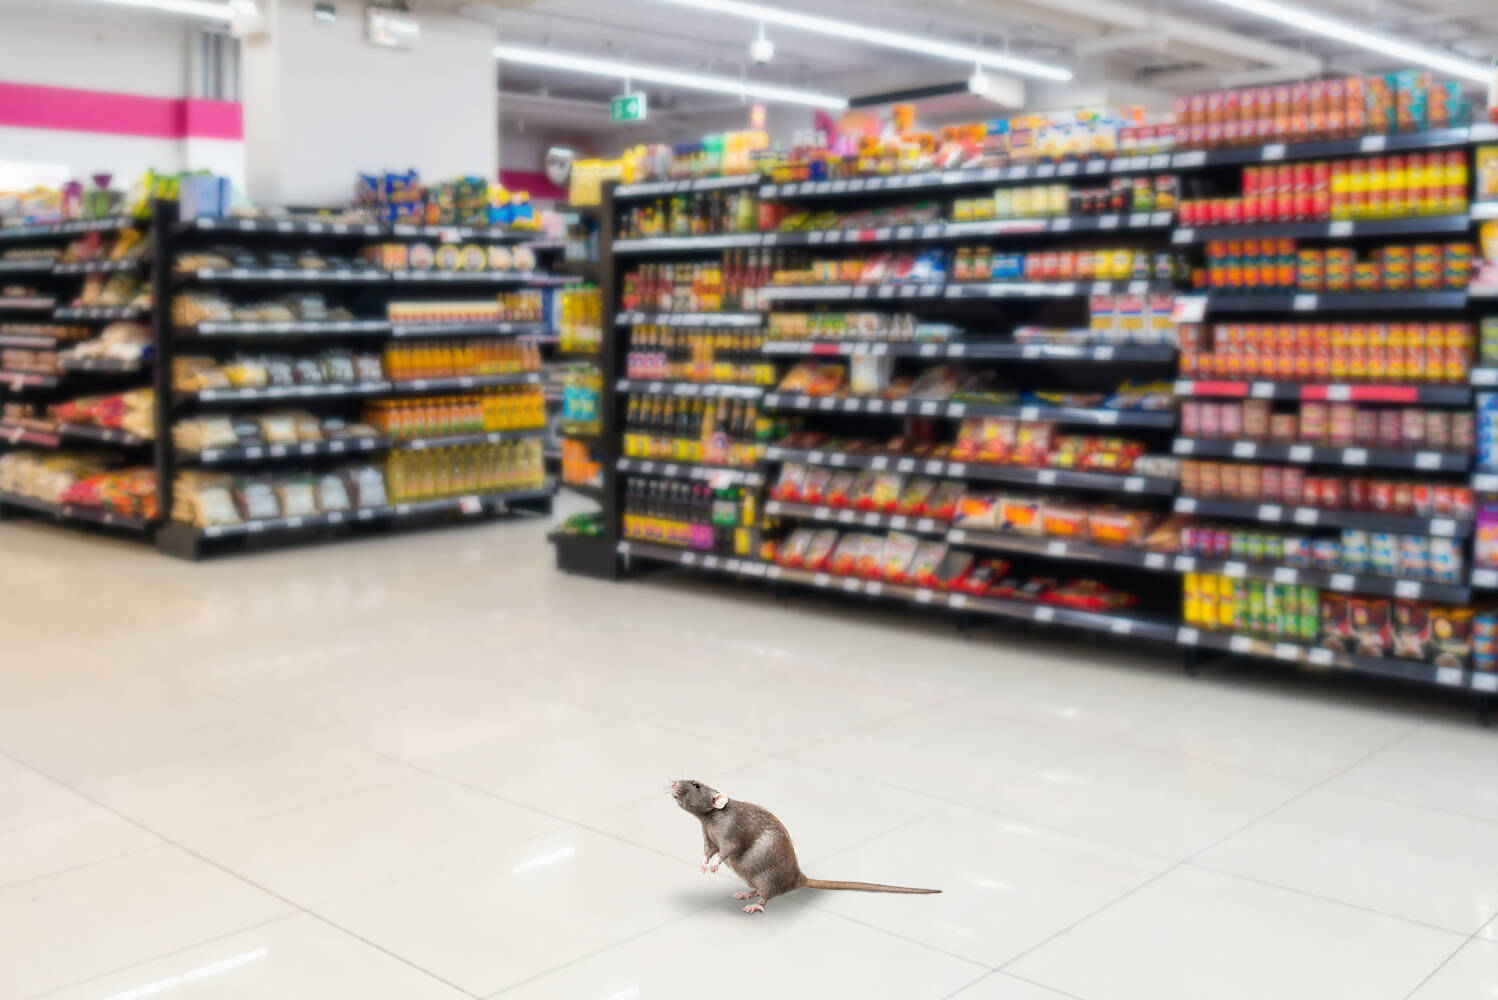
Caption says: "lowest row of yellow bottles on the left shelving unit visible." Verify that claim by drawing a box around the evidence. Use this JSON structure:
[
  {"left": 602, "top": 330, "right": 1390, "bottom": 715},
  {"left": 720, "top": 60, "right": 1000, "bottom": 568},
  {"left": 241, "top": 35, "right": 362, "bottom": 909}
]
[{"left": 385, "top": 439, "right": 545, "bottom": 503}]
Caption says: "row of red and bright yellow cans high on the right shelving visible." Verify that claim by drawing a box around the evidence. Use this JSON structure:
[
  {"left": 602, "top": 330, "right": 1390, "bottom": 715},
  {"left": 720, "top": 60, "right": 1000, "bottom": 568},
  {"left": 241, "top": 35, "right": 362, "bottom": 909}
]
[{"left": 1180, "top": 150, "right": 1468, "bottom": 226}]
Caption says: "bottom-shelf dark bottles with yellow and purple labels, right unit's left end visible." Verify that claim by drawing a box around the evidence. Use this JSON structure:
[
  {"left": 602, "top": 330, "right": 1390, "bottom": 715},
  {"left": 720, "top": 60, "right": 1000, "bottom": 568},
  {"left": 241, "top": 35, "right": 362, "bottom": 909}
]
[{"left": 625, "top": 476, "right": 755, "bottom": 555}]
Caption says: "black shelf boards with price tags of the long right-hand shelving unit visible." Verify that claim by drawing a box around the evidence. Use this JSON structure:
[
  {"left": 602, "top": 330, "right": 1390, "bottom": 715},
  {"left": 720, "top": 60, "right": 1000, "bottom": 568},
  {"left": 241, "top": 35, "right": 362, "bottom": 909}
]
[{"left": 560, "top": 126, "right": 1498, "bottom": 704}]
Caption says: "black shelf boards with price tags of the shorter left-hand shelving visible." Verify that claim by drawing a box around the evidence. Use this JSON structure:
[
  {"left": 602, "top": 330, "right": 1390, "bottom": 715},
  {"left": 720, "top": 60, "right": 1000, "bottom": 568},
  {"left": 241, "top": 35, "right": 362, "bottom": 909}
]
[{"left": 0, "top": 202, "right": 572, "bottom": 558}]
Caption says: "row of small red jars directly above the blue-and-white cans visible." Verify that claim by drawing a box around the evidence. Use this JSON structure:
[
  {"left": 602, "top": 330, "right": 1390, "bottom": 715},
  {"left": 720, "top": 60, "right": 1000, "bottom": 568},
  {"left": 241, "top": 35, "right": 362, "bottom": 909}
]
[{"left": 1180, "top": 460, "right": 1473, "bottom": 519}]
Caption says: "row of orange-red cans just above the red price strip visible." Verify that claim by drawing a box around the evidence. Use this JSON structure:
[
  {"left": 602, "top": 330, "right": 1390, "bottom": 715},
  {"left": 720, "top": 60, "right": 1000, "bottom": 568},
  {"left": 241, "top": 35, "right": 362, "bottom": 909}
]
[{"left": 1180, "top": 322, "right": 1474, "bottom": 383}]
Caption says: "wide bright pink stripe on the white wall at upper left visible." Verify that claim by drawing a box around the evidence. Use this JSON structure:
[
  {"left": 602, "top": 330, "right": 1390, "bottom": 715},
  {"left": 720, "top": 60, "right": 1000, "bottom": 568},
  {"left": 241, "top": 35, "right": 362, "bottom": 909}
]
[{"left": 0, "top": 81, "right": 244, "bottom": 139}]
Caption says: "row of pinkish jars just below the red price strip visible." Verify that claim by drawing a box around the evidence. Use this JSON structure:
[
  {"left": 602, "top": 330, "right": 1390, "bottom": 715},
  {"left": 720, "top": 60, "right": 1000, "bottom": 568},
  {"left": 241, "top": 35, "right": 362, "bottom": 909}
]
[{"left": 1180, "top": 400, "right": 1476, "bottom": 454}]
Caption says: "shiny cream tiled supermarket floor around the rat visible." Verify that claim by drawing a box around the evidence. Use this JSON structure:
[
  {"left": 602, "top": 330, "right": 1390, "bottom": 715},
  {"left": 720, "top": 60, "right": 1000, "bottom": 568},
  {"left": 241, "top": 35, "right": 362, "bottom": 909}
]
[{"left": 0, "top": 524, "right": 1498, "bottom": 1000}]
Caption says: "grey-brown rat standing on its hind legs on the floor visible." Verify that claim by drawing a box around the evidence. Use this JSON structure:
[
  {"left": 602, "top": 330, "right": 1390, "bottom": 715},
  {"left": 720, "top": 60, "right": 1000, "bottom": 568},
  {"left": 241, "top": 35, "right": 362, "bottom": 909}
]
[{"left": 667, "top": 780, "right": 941, "bottom": 913}]
